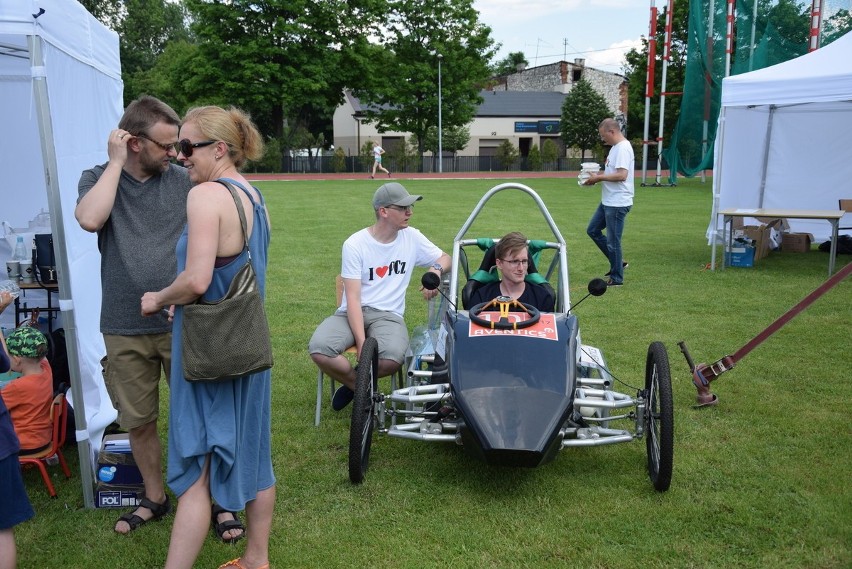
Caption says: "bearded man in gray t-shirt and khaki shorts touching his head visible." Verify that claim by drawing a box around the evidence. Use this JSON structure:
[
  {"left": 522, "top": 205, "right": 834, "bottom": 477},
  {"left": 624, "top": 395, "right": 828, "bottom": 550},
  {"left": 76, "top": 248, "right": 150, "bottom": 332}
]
[{"left": 74, "top": 96, "right": 192, "bottom": 533}]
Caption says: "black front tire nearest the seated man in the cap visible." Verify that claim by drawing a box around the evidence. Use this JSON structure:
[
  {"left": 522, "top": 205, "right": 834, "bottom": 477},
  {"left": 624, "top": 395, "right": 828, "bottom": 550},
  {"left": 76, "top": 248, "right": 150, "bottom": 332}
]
[{"left": 349, "top": 338, "right": 379, "bottom": 484}]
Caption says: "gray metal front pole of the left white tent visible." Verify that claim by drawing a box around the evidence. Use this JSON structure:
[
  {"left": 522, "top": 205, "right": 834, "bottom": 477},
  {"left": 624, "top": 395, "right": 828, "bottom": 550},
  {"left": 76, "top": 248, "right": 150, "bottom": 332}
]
[{"left": 27, "top": 35, "right": 95, "bottom": 508}]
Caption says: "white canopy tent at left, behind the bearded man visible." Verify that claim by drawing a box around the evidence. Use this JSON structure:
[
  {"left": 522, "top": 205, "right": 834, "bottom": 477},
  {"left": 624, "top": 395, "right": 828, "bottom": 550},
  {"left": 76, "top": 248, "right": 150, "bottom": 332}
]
[{"left": 0, "top": 0, "right": 123, "bottom": 508}]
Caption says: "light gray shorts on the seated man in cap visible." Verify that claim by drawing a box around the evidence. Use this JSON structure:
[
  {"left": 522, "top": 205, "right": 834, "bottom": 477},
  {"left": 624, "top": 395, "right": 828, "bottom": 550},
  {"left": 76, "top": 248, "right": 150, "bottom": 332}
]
[{"left": 308, "top": 307, "right": 408, "bottom": 364}]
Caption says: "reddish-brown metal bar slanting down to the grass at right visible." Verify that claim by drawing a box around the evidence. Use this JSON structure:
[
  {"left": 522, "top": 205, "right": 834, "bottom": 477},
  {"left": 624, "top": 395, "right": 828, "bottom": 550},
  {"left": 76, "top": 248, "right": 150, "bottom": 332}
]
[{"left": 678, "top": 263, "right": 852, "bottom": 407}]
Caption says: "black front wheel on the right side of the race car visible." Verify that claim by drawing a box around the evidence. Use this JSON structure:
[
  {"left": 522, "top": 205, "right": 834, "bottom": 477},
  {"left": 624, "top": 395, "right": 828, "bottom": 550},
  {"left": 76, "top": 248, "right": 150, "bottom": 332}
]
[{"left": 645, "top": 342, "right": 674, "bottom": 492}]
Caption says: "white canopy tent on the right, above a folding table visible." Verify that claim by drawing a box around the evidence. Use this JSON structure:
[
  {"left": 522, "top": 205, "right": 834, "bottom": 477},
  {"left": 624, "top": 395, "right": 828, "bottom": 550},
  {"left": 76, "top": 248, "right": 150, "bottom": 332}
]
[{"left": 708, "top": 32, "right": 852, "bottom": 241}]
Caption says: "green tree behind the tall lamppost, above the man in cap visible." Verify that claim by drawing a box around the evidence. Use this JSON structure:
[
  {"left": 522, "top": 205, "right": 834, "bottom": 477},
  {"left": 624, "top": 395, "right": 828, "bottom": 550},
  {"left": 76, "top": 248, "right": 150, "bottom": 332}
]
[{"left": 354, "top": 0, "right": 494, "bottom": 169}]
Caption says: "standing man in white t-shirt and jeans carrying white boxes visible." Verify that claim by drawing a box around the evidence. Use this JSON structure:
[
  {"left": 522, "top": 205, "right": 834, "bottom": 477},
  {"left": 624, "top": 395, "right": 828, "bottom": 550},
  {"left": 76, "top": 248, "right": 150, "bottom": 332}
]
[{"left": 584, "top": 119, "right": 634, "bottom": 286}]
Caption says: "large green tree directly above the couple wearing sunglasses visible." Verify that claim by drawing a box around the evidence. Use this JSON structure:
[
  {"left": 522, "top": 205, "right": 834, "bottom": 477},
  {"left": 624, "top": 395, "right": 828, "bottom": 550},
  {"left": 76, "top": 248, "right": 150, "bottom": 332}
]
[{"left": 173, "top": 0, "right": 384, "bottom": 154}]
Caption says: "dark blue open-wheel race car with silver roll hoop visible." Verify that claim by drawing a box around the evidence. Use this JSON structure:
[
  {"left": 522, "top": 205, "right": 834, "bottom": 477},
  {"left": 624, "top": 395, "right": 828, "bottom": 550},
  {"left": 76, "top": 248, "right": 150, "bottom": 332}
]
[{"left": 349, "top": 183, "right": 674, "bottom": 492}]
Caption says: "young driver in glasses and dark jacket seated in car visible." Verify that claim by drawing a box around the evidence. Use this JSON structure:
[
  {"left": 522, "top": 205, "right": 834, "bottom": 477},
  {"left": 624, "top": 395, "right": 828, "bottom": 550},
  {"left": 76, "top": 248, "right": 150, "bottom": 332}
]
[{"left": 470, "top": 231, "right": 555, "bottom": 312}]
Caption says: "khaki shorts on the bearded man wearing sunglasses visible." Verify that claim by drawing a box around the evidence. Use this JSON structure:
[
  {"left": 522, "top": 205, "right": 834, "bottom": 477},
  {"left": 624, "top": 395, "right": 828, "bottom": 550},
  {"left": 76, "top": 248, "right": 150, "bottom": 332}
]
[{"left": 101, "top": 332, "right": 172, "bottom": 429}]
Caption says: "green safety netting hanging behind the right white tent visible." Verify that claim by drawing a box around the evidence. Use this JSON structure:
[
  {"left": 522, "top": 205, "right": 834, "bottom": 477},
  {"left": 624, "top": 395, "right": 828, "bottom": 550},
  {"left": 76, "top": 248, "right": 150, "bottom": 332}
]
[{"left": 663, "top": 0, "right": 852, "bottom": 184}]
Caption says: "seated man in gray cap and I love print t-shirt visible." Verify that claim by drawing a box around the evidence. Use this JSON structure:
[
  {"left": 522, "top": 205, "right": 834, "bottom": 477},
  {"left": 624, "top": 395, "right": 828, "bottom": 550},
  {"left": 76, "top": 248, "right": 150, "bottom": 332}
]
[{"left": 308, "top": 182, "right": 452, "bottom": 411}]
